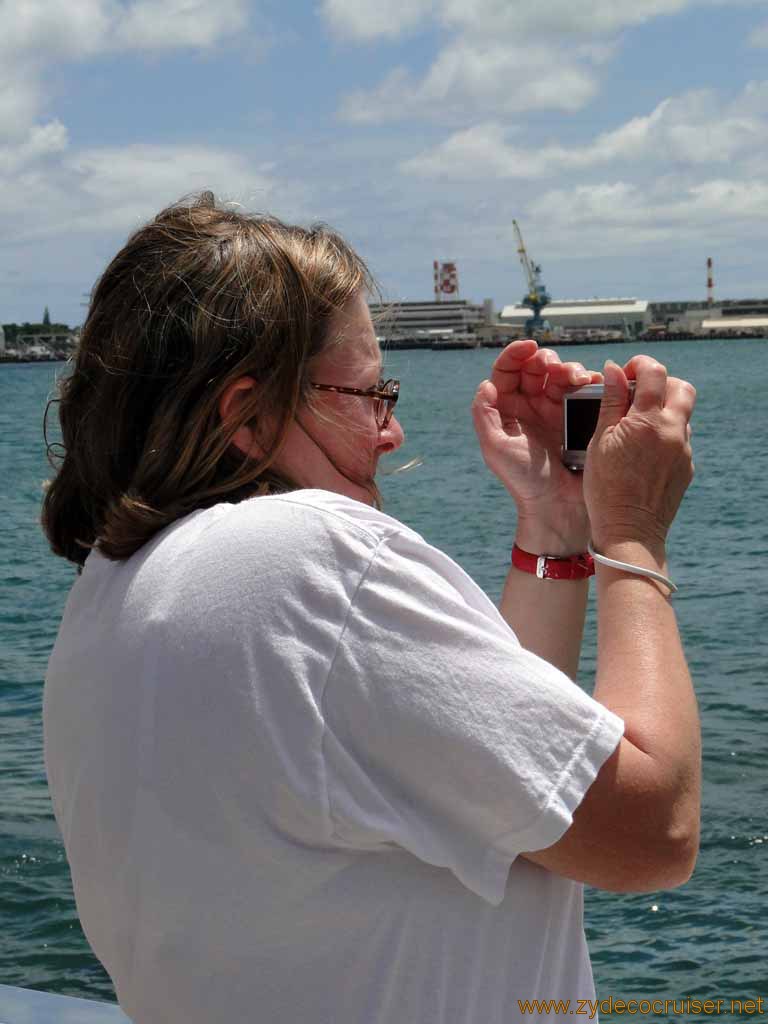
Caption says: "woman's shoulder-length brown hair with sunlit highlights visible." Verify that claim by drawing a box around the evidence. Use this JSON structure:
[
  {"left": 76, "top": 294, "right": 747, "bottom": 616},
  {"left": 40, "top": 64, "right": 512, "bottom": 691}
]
[{"left": 42, "top": 193, "right": 372, "bottom": 564}]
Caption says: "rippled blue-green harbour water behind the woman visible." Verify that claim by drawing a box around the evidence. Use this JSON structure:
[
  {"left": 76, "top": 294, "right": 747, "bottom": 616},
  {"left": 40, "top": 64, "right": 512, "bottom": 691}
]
[{"left": 0, "top": 341, "right": 768, "bottom": 1011}]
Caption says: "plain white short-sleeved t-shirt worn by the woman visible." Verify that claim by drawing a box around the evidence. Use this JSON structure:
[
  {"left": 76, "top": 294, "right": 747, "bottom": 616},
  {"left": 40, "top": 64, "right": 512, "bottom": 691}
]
[{"left": 44, "top": 490, "right": 623, "bottom": 1024}]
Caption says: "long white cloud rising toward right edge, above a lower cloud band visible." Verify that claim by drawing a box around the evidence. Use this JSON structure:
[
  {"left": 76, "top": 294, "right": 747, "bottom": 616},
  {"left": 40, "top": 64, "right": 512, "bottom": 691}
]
[{"left": 400, "top": 82, "right": 768, "bottom": 180}]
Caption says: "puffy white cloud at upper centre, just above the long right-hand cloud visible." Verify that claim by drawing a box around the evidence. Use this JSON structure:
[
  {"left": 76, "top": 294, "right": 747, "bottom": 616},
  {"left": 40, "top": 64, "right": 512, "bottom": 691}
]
[{"left": 340, "top": 40, "right": 596, "bottom": 124}]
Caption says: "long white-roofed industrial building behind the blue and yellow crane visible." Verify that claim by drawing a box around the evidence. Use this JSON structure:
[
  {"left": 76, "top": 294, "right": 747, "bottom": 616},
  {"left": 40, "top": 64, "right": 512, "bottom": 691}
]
[{"left": 500, "top": 299, "right": 652, "bottom": 338}]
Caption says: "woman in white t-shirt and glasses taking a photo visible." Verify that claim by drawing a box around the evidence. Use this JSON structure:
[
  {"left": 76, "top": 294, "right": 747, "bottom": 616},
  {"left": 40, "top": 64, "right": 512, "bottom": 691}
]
[{"left": 43, "top": 194, "right": 699, "bottom": 1024}]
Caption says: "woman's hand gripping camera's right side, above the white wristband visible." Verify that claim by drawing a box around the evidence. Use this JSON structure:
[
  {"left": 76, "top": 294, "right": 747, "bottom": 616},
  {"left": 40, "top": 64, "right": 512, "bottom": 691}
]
[{"left": 584, "top": 355, "right": 696, "bottom": 558}]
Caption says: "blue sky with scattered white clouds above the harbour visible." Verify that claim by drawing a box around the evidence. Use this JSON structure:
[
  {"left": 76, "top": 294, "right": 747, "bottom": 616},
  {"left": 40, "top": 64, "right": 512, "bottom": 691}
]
[{"left": 0, "top": 0, "right": 768, "bottom": 324}]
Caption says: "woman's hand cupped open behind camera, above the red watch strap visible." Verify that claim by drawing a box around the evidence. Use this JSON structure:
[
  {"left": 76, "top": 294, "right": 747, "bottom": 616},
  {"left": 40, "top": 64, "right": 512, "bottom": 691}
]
[{"left": 472, "top": 339, "right": 602, "bottom": 555}]
